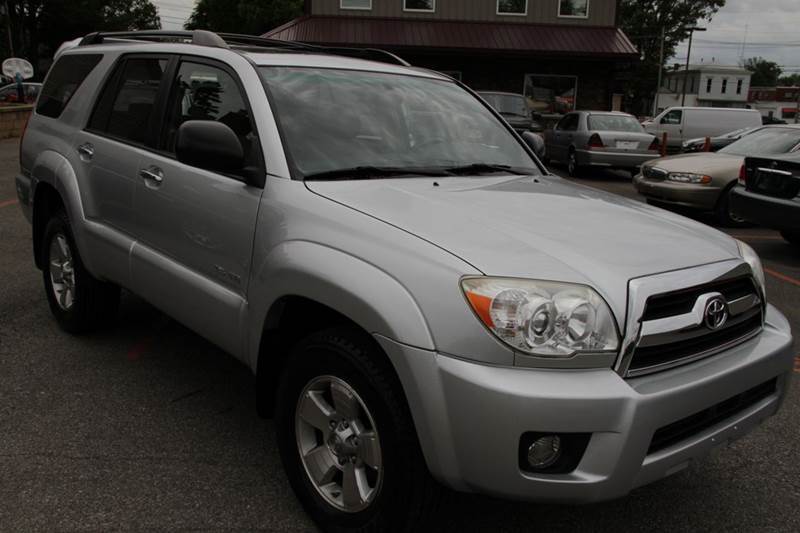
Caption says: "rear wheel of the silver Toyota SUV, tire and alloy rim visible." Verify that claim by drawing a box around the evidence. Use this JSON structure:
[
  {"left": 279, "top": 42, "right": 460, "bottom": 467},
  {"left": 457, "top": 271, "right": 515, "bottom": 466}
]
[{"left": 42, "top": 211, "right": 119, "bottom": 333}]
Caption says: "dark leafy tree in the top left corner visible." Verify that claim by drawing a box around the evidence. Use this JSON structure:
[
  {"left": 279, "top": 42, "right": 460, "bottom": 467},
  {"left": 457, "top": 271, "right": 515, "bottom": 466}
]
[{"left": 0, "top": 0, "right": 161, "bottom": 78}]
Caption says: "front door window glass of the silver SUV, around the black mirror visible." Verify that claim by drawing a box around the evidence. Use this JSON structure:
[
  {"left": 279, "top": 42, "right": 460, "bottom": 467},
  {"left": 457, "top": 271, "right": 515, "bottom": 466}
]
[{"left": 162, "top": 61, "right": 260, "bottom": 166}]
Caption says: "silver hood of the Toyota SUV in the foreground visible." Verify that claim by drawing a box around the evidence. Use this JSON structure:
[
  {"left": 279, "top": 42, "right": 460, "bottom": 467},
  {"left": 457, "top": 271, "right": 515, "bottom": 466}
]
[{"left": 307, "top": 176, "right": 738, "bottom": 317}]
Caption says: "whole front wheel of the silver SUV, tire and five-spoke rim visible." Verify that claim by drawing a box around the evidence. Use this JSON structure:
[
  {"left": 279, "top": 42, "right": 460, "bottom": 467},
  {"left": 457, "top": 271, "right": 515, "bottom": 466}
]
[{"left": 276, "top": 328, "right": 441, "bottom": 532}]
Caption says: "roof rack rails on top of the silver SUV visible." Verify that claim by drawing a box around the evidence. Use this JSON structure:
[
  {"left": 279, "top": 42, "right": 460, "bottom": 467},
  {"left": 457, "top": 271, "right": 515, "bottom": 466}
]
[{"left": 78, "top": 30, "right": 411, "bottom": 67}]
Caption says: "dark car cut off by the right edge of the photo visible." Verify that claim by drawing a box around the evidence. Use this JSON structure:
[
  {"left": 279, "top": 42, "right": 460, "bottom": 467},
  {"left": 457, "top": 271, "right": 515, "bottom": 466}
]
[{"left": 731, "top": 153, "right": 800, "bottom": 247}]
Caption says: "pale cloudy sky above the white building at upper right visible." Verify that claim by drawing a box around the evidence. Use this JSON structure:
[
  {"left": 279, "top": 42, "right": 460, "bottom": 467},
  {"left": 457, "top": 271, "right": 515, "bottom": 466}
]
[{"left": 669, "top": 0, "right": 800, "bottom": 74}]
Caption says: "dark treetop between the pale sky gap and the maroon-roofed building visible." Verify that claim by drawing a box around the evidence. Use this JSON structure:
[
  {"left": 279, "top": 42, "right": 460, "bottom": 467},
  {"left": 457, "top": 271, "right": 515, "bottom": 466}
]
[{"left": 186, "top": 0, "right": 303, "bottom": 35}]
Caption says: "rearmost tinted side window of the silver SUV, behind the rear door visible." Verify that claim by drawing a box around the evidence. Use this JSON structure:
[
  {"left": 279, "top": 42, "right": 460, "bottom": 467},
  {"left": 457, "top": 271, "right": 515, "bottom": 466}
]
[{"left": 36, "top": 54, "right": 103, "bottom": 118}]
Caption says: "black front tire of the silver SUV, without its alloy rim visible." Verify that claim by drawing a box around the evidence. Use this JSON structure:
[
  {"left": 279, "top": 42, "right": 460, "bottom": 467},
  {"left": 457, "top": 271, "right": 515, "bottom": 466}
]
[{"left": 275, "top": 328, "right": 444, "bottom": 532}]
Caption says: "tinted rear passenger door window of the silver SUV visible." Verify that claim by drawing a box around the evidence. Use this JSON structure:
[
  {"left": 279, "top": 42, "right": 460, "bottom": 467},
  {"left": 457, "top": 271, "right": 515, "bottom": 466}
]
[{"left": 89, "top": 57, "right": 168, "bottom": 144}]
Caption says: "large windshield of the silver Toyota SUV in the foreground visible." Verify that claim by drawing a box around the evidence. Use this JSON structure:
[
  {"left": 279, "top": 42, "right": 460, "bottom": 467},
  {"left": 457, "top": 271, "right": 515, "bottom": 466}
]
[{"left": 260, "top": 67, "right": 540, "bottom": 179}]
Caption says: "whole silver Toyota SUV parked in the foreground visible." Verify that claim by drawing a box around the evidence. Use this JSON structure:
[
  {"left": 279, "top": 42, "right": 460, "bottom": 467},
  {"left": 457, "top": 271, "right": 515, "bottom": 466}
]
[{"left": 17, "top": 32, "right": 793, "bottom": 531}]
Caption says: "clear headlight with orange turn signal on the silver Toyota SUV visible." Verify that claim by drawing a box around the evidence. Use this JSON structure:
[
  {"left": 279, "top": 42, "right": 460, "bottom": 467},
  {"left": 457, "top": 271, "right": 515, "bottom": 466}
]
[{"left": 461, "top": 278, "right": 619, "bottom": 358}]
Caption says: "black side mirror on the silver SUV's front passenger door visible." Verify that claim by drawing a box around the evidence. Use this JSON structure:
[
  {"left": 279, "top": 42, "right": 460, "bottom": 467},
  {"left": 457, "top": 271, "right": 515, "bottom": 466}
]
[{"left": 175, "top": 120, "right": 244, "bottom": 172}]
